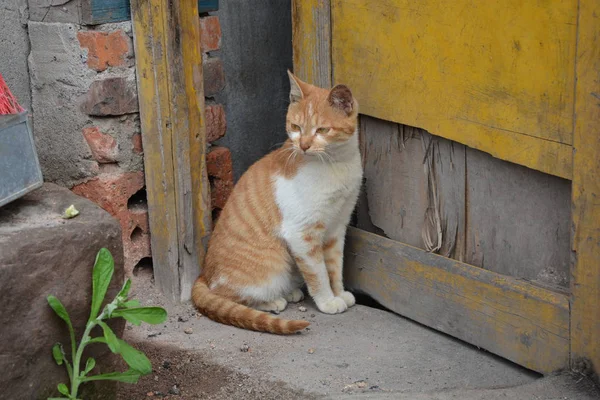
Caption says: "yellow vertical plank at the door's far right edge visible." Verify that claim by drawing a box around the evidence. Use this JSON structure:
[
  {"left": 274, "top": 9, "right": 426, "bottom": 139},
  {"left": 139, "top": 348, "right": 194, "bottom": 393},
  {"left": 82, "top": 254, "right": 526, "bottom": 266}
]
[{"left": 571, "top": 0, "right": 600, "bottom": 379}]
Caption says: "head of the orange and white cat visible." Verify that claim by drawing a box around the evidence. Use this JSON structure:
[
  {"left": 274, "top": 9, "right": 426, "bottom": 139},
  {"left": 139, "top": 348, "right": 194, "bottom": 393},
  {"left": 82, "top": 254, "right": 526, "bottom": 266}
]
[{"left": 286, "top": 71, "right": 358, "bottom": 154}]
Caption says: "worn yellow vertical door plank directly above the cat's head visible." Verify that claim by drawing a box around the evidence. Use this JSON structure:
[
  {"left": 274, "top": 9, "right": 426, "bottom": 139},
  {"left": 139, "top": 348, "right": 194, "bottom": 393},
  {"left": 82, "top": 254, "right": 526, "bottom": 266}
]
[{"left": 292, "top": 0, "right": 333, "bottom": 88}]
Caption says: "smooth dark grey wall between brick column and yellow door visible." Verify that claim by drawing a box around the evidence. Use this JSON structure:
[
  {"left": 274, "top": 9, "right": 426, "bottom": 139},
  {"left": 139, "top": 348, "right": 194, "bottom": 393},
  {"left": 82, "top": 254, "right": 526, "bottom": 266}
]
[{"left": 215, "top": 0, "right": 292, "bottom": 180}]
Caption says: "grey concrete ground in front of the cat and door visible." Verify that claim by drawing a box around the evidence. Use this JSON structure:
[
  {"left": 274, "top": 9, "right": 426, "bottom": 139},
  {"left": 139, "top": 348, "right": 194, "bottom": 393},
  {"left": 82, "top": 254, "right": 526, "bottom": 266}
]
[{"left": 126, "top": 272, "right": 600, "bottom": 400}]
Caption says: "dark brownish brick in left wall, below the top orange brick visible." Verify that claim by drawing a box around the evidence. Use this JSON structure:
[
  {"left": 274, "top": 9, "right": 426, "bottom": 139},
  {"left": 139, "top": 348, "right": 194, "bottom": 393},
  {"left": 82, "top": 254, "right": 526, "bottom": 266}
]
[{"left": 81, "top": 77, "right": 139, "bottom": 117}]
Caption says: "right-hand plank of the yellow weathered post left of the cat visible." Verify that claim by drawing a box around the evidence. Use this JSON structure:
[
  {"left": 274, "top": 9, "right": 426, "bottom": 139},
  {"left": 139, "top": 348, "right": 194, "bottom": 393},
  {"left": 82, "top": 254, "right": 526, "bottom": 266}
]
[{"left": 167, "top": 0, "right": 211, "bottom": 301}]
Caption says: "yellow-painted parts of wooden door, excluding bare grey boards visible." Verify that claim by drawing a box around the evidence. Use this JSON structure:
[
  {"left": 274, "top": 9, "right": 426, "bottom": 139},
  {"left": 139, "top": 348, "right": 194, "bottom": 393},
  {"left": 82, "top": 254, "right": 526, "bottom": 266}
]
[{"left": 293, "top": 0, "right": 600, "bottom": 373}]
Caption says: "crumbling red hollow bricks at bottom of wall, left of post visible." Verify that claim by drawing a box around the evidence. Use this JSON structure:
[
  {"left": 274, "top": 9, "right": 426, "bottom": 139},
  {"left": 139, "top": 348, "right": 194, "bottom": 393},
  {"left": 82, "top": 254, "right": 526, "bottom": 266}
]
[{"left": 72, "top": 170, "right": 150, "bottom": 276}]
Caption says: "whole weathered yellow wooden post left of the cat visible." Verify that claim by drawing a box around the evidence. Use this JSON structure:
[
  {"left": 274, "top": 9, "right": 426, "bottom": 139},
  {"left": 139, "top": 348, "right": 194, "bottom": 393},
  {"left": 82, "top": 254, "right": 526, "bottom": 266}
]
[{"left": 131, "top": 0, "right": 211, "bottom": 301}]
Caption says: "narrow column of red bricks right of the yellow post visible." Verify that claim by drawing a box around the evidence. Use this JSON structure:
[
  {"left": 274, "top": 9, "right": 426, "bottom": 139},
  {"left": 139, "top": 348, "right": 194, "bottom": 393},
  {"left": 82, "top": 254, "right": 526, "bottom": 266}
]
[{"left": 200, "top": 14, "right": 233, "bottom": 220}]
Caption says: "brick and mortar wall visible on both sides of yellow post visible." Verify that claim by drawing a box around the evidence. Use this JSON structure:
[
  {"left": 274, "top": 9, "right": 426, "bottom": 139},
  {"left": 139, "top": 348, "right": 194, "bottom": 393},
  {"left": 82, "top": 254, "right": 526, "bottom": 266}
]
[{"left": 28, "top": 7, "right": 233, "bottom": 274}]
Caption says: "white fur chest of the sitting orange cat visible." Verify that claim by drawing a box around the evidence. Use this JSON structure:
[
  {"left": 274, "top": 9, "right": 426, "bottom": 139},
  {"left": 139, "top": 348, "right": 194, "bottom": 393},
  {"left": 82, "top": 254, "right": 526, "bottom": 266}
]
[{"left": 274, "top": 153, "right": 362, "bottom": 236}]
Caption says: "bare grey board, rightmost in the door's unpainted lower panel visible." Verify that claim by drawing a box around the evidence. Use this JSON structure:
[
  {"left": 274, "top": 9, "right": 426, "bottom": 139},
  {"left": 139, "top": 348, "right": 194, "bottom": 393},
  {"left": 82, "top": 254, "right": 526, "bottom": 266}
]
[{"left": 465, "top": 148, "right": 571, "bottom": 290}]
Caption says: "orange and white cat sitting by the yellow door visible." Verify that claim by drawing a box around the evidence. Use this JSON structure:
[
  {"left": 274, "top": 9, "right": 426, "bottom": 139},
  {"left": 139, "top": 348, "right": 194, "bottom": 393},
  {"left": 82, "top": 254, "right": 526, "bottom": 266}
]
[{"left": 192, "top": 71, "right": 363, "bottom": 334}]
